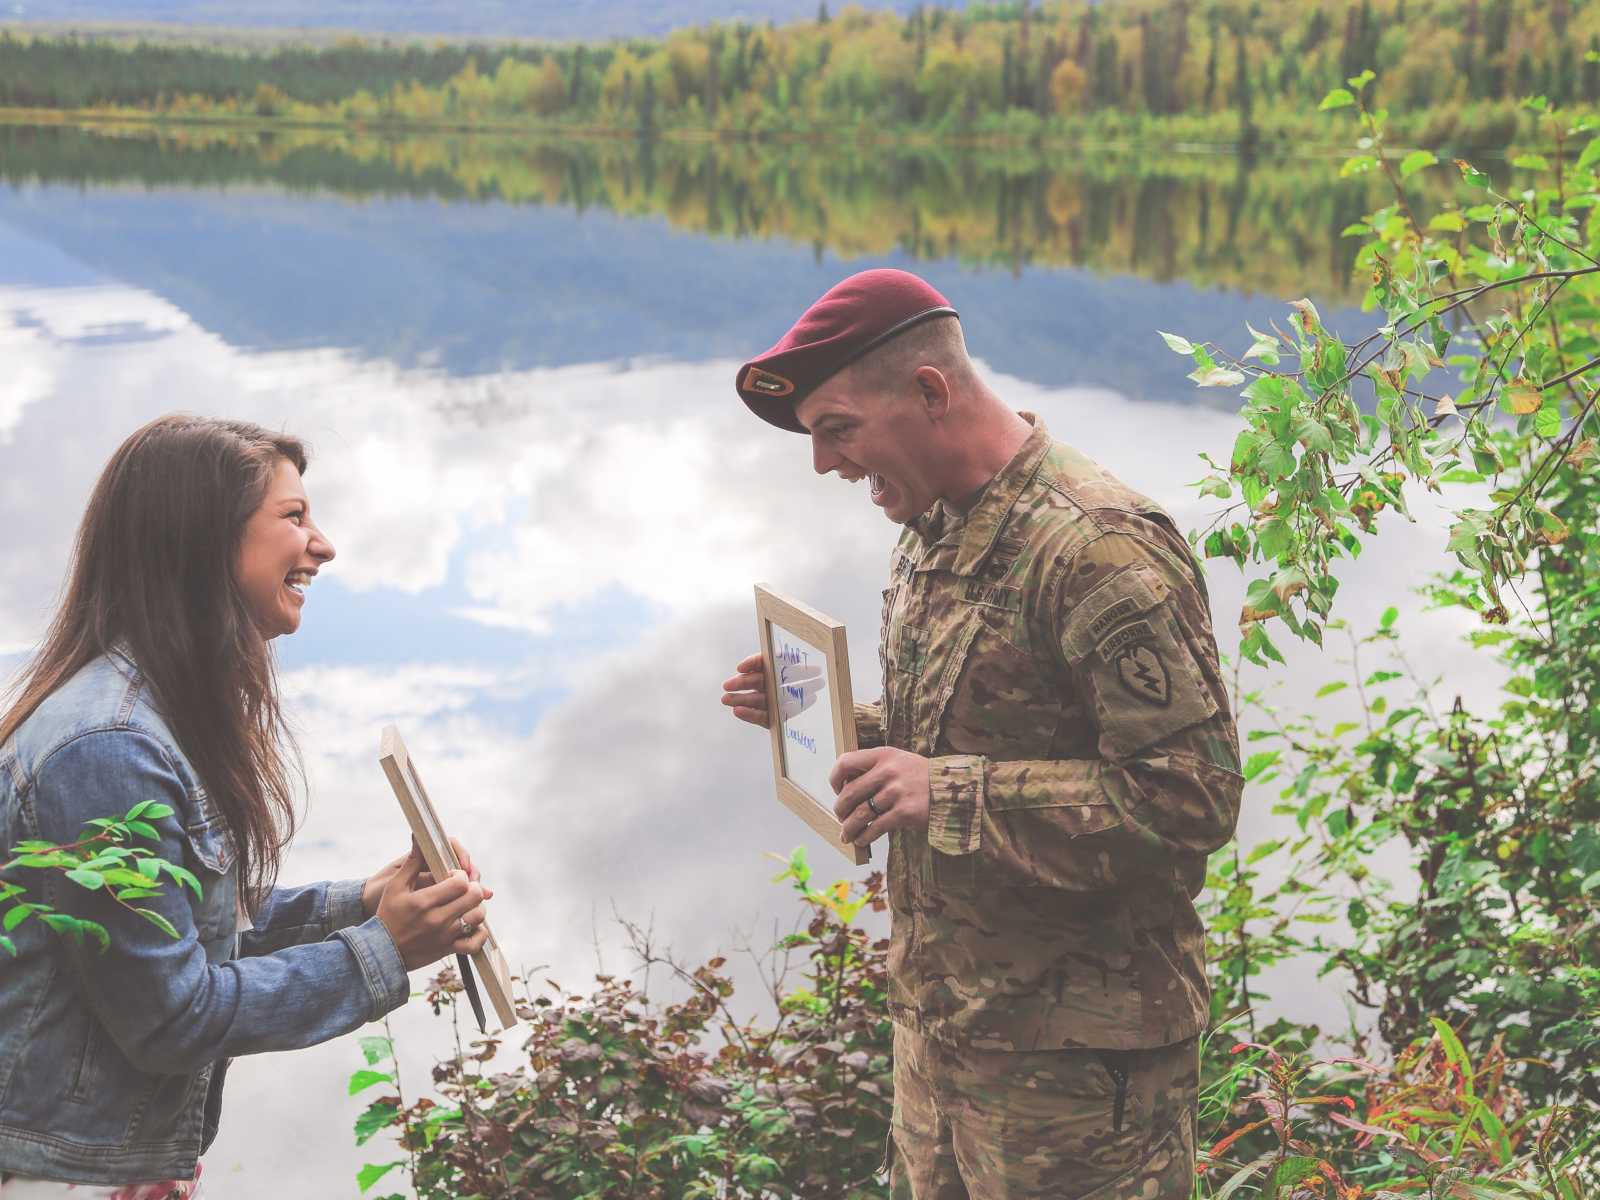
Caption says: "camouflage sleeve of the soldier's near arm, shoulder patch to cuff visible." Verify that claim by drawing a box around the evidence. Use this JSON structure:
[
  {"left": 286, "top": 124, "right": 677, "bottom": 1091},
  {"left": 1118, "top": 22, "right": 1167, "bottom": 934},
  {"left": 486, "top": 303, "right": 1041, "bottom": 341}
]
[{"left": 928, "top": 533, "right": 1243, "bottom": 891}]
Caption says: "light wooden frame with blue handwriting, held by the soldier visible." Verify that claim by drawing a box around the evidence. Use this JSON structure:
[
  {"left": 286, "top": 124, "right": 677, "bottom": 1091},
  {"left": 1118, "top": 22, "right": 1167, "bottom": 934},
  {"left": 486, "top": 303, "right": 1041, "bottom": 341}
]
[{"left": 755, "top": 584, "right": 872, "bottom": 867}]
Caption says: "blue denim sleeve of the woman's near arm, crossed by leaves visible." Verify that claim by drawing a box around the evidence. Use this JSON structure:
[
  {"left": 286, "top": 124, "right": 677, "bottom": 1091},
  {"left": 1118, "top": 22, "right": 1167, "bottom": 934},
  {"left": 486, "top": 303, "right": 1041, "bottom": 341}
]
[{"left": 35, "top": 730, "right": 410, "bottom": 1074}]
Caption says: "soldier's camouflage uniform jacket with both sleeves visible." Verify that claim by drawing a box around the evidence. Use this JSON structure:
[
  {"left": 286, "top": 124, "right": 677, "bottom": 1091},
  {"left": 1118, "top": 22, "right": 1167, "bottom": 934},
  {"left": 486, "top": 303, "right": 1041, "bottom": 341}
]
[{"left": 856, "top": 414, "right": 1243, "bottom": 1051}]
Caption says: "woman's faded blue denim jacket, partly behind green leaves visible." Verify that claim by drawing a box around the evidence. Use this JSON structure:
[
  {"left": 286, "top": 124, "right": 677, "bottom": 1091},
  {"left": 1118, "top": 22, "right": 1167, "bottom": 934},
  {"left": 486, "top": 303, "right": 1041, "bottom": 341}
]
[{"left": 0, "top": 651, "right": 410, "bottom": 1184}]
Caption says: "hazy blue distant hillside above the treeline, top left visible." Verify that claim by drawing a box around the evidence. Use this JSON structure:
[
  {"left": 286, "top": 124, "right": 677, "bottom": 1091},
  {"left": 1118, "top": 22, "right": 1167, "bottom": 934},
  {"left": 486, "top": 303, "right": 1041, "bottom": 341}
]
[{"left": 0, "top": 0, "right": 921, "bottom": 40}]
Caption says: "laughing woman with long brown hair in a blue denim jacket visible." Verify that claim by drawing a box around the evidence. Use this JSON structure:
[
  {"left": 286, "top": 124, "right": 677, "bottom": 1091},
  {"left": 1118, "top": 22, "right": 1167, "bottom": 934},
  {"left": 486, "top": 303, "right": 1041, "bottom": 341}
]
[{"left": 0, "top": 416, "right": 491, "bottom": 1200}]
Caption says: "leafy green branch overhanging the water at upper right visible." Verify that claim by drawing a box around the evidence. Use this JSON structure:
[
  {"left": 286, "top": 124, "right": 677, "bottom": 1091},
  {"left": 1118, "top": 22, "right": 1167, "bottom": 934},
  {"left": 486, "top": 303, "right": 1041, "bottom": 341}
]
[{"left": 1162, "top": 72, "right": 1600, "bottom": 664}]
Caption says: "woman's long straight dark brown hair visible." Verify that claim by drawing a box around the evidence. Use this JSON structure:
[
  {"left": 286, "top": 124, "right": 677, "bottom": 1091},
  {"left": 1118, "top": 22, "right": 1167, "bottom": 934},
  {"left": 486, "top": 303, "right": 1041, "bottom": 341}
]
[{"left": 0, "top": 414, "right": 307, "bottom": 909}]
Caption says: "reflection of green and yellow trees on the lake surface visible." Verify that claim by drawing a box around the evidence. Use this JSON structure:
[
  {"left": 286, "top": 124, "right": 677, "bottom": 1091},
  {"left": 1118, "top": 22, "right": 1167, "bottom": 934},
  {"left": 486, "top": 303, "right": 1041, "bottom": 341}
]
[{"left": 0, "top": 125, "right": 1497, "bottom": 301}]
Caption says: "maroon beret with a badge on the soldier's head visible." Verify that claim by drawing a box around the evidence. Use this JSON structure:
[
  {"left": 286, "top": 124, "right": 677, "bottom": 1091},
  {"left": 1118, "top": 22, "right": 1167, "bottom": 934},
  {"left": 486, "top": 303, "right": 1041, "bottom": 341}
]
[{"left": 734, "top": 269, "right": 955, "bottom": 434}]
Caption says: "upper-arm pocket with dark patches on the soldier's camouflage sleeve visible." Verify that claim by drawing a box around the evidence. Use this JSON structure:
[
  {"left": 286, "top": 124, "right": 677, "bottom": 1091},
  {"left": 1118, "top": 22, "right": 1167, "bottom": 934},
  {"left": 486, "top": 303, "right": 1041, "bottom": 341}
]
[{"left": 1061, "top": 563, "right": 1218, "bottom": 755}]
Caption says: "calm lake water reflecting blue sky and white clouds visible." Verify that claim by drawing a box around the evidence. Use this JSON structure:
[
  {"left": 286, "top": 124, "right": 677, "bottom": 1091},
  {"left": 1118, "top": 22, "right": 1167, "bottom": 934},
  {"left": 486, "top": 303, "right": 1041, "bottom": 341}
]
[{"left": 0, "top": 127, "right": 1482, "bottom": 1200}]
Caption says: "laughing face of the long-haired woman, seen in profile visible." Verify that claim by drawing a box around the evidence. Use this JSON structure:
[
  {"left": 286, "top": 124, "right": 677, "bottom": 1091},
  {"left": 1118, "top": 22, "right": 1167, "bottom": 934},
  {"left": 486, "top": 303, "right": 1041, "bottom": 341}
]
[{"left": 234, "top": 459, "right": 333, "bottom": 638}]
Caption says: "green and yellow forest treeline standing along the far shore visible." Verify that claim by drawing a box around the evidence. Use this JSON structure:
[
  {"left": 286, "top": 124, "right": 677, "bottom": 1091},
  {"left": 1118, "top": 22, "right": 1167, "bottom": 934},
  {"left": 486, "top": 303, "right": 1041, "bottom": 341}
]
[{"left": 9, "top": 0, "right": 1600, "bottom": 146}]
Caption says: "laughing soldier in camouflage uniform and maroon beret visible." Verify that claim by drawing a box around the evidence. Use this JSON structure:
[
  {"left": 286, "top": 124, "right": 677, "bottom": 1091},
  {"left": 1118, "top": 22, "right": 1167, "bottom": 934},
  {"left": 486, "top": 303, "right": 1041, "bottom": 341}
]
[{"left": 722, "top": 270, "right": 1243, "bottom": 1200}]
